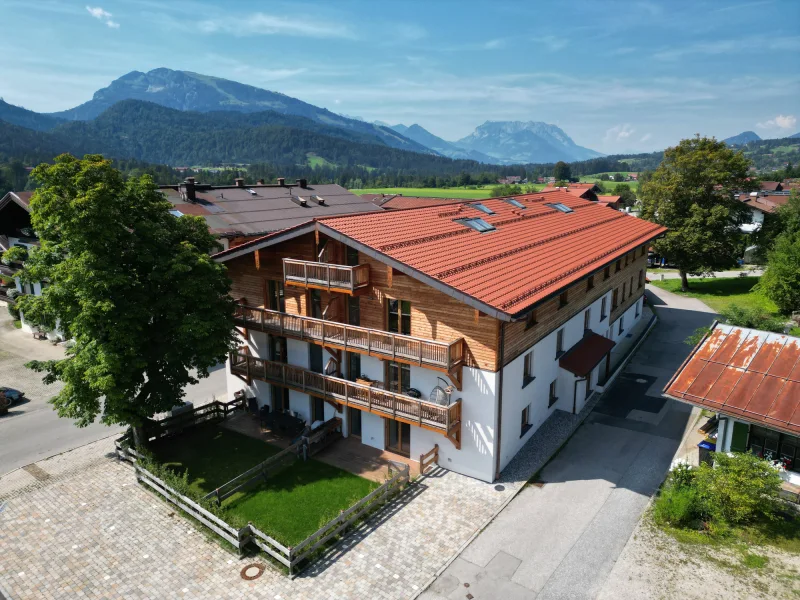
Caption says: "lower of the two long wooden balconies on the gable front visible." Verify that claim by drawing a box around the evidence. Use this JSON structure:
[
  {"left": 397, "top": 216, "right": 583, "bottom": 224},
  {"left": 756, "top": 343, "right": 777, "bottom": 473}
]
[{"left": 230, "top": 349, "right": 461, "bottom": 448}]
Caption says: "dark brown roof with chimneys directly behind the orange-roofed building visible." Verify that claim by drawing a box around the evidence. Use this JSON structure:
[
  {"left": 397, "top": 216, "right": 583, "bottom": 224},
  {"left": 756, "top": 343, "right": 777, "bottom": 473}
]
[{"left": 160, "top": 177, "right": 380, "bottom": 248}]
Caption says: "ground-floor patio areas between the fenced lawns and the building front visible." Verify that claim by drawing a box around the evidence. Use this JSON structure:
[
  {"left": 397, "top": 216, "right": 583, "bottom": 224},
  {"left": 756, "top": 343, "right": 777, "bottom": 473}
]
[{"left": 220, "top": 413, "right": 419, "bottom": 483}]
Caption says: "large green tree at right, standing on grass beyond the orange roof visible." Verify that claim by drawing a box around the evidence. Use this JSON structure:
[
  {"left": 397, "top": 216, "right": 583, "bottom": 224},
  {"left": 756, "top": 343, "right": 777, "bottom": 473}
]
[{"left": 639, "top": 136, "right": 758, "bottom": 290}]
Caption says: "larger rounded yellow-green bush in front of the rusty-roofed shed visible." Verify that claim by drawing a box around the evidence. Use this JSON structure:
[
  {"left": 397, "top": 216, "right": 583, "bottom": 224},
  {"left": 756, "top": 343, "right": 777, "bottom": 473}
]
[{"left": 693, "top": 452, "right": 781, "bottom": 524}]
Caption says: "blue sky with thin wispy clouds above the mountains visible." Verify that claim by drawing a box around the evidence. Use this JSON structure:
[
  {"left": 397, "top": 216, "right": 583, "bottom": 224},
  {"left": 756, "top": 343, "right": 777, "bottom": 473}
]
[{"left": 0, "top": 0, "right": 800, "bottom": 153}]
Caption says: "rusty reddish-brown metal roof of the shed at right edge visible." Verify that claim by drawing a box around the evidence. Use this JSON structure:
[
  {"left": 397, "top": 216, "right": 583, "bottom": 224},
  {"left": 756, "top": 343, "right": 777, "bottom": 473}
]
[{"left": 664, "top": 323, "right": 800, "bottom": 435}]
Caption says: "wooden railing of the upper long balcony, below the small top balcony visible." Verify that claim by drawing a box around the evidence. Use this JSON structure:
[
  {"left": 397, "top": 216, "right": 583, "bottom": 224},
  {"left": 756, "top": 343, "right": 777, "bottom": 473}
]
[{"left": 234, "top": 304, "right": 464, "bottom": 371}]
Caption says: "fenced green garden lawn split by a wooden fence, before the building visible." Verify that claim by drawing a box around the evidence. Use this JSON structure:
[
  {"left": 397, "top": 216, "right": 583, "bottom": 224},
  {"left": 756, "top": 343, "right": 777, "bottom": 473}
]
[{"left": 151, "top": 425, "right": 378, "bottom": 545}]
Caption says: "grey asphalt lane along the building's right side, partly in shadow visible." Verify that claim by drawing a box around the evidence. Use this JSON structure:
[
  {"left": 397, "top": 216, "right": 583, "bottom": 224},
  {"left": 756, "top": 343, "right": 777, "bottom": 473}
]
[{"left": 421, "top": 289, "right": 714, "bottom": 600}]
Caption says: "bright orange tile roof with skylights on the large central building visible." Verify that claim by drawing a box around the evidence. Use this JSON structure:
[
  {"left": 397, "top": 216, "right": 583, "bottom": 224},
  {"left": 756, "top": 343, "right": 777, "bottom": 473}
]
[{"left": 318, "top": 190, "right": 666, "bottom": 315}]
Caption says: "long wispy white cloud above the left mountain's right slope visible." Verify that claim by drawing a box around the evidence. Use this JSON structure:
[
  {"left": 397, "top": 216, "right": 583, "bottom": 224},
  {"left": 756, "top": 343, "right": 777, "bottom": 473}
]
[{"left": 192, "top": 13, "right": 355, "bottom": 39}]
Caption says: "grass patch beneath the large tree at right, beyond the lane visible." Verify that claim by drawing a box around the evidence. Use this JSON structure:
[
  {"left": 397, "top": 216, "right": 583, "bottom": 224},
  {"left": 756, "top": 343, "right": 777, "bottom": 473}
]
[{"left": 651, "top": 277, "right": 779, "bottom": 315}]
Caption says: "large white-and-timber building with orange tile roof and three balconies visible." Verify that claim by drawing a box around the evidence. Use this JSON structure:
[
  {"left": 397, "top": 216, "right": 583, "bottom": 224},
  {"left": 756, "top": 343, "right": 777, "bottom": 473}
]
[{"left": 215, "top": 190, "right": 666, "bottom": 481}]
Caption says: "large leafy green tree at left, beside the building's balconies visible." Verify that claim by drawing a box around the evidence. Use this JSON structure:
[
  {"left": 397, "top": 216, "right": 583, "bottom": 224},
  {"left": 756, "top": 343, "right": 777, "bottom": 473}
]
[{"left": 18, "top": 154, "right": 234, "bottom": 446}]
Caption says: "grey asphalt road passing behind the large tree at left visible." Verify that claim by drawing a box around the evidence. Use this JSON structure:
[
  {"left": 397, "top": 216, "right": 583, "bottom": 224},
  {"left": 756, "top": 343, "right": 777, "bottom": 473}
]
[{"left": 0, "top": 303, "right": 226, "bottom": 475}]
